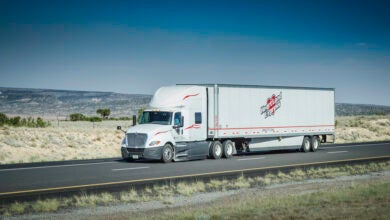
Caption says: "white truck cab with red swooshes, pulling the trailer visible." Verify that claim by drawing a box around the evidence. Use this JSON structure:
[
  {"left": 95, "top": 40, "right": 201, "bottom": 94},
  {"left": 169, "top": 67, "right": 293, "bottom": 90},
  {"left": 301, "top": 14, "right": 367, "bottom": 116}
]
[{"left": 121, "top": 86, "right": 208, "bottom": 162}]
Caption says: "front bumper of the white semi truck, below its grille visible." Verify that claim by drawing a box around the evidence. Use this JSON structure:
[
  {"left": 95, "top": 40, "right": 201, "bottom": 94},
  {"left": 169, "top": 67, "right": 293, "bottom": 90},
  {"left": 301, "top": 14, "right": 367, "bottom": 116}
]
[{"left": 121, "top": 146, "right": 162, "bottom": 160}]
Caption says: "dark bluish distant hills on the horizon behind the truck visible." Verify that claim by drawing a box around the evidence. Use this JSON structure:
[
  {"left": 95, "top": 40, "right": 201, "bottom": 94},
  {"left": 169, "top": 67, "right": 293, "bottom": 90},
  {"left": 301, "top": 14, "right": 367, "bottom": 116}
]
[{"left": 0, "top": 87, "right": 390, "bottom": 118}]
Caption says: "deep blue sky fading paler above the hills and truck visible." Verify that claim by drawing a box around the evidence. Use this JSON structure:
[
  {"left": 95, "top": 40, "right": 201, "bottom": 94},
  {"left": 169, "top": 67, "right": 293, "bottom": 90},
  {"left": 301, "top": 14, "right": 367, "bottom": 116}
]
[{"left": 0, "top": 0, "right": 390, "bottom": 105}]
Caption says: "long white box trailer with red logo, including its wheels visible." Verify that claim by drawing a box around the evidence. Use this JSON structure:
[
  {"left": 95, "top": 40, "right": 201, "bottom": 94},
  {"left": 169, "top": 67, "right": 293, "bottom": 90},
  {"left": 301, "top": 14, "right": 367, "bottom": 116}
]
[{"left": 180, "top": 84, "right": 335, "bottom": 158}]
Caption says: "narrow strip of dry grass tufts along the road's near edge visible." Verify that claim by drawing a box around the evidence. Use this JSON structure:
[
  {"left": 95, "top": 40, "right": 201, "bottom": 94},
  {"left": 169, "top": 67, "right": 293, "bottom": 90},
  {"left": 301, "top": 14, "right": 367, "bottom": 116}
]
[{"left": 0, "top": 160, "right": 390, "bottom": 219}]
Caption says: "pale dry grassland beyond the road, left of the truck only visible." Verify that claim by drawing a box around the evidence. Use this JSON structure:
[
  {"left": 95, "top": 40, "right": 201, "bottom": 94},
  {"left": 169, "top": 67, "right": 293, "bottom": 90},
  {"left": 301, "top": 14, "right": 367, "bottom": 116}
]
[{"left": 0, "top": 121, "right": 131, "bottom": 164}]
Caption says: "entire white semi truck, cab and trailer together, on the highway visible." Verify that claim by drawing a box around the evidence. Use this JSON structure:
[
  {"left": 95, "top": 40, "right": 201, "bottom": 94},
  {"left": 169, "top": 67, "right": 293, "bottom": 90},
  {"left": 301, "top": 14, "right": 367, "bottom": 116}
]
[{"left": 118, "top": 84, "right": 335, "bottom": 163}]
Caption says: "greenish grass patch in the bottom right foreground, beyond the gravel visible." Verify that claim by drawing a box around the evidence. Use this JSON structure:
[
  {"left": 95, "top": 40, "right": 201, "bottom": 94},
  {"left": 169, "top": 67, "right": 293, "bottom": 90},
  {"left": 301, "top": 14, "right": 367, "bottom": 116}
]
[{"left": 142, "top": 179, "right": 390, "bottom": 220}]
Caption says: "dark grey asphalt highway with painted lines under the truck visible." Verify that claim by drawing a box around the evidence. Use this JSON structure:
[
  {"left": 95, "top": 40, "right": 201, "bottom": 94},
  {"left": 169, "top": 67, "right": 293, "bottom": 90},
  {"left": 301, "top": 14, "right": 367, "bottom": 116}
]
[{"left": 0, "top": 143, "right": 390, "bottom": 197}]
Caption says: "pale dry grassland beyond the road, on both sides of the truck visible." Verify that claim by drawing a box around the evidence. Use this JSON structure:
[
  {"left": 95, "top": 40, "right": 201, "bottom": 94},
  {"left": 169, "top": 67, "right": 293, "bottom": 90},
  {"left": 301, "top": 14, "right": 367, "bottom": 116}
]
[{"left": 0, "top": 115, "right": 390, "bottom": 164}]
